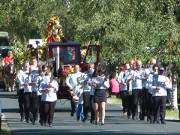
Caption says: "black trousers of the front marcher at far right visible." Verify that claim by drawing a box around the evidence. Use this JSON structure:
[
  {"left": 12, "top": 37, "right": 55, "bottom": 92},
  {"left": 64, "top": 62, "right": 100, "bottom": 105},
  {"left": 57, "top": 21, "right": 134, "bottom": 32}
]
[{"left": 154, "top": 96, "right": 166, "bottom": 122}]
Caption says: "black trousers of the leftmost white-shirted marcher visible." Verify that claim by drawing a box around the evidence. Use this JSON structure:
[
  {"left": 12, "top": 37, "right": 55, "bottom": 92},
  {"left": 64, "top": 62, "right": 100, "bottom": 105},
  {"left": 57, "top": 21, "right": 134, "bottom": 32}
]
[{"left": 17, "top": 89, "right": 25, "bottom": 118}]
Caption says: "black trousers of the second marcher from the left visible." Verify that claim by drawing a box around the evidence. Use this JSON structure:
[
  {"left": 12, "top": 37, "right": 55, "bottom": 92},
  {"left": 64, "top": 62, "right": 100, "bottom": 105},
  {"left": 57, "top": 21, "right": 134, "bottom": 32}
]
[{"left": 23, "top": 92, "right": 31, "bottom": 121}]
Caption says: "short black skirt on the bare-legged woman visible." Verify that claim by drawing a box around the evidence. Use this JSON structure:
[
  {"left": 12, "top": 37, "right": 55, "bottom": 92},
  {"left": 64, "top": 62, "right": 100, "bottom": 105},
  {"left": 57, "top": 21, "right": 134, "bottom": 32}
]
[{"left": 94, "top": 89, "right": 106, "bottom": 103}]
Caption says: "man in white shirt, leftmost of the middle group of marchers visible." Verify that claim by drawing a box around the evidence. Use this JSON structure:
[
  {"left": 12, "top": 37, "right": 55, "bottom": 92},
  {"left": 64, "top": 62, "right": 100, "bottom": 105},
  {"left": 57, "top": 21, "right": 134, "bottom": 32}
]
[{"left": 66, "top": 65, "right": 83, "bottom": 116}]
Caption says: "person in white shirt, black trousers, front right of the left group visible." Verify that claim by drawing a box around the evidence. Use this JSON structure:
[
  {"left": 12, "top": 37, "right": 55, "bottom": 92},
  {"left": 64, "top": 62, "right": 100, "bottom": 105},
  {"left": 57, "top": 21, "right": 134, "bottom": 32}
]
[{"left": 39, "top": 69, "right": 58, "bottom": 127}]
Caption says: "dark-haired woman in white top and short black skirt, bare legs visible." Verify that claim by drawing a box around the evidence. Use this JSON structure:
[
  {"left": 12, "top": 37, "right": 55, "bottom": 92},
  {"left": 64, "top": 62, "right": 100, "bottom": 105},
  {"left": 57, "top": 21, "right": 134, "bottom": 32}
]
[{"left": 92, "top": 68, "right": 109, "bottom": 125}]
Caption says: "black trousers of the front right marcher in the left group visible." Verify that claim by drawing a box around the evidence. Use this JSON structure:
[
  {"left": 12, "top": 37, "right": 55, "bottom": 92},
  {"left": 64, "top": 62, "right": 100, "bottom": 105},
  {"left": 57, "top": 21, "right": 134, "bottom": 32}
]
[{"left": 42, "top": 101, "right": 56, "bottom": 124}]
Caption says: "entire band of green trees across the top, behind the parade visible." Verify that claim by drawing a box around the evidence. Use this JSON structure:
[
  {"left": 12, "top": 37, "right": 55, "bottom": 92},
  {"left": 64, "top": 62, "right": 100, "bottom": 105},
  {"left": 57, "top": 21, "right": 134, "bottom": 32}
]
[{"left": 0, "top": 0, "right": 180, "bottom": 64}]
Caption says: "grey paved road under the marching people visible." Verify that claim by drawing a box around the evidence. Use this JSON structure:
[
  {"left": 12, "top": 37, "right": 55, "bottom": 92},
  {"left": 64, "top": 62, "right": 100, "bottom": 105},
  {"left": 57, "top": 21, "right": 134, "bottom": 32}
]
[{"left": 0, "top": 92, "right": 180, "bottom": 135}]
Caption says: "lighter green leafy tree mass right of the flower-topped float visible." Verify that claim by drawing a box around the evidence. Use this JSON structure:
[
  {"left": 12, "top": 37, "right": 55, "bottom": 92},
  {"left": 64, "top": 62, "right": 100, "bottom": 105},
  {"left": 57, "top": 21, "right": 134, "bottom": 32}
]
[{"left": 69, "top": 0, "right": 177, "bottom": 63}]
